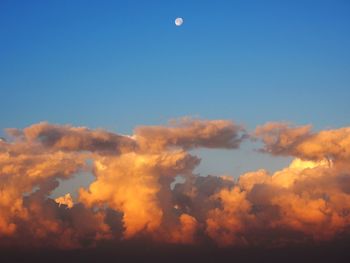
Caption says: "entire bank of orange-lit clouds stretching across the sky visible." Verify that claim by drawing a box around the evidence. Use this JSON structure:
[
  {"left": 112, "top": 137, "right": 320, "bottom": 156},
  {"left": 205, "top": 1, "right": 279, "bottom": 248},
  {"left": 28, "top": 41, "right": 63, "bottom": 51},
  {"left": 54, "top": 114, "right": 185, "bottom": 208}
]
[{"left": 0, "top": 118, "right": 350, "bottom": 249}]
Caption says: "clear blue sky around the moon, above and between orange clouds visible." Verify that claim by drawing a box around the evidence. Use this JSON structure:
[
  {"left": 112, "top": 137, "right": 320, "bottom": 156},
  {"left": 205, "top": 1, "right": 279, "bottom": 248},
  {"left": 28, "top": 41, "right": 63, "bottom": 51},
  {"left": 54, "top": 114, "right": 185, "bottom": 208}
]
[{"left": 0, "top": 0, "right": 350, "bottom": 188}]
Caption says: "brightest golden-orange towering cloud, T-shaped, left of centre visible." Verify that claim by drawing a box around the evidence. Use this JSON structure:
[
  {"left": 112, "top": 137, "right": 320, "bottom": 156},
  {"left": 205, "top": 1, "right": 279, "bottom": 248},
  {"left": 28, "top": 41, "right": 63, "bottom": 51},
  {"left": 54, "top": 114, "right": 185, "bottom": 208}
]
[{"left": 80, "top": 151, "right": 198, "bottom": 238}]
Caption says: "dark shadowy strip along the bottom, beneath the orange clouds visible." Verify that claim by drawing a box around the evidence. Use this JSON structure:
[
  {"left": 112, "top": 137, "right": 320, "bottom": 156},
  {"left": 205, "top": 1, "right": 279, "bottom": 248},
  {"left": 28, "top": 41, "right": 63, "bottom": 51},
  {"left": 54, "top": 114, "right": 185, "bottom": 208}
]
[{"left": 0, "top": 241, "right": 350, "bottom": 263}]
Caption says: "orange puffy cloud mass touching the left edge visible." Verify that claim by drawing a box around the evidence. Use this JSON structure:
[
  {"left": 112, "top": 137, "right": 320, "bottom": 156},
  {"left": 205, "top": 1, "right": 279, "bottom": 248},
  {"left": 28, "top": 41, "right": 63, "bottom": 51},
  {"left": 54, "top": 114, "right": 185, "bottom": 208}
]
[{"left": 0, "top": 143, "right": 85, "bottom": 240}]
